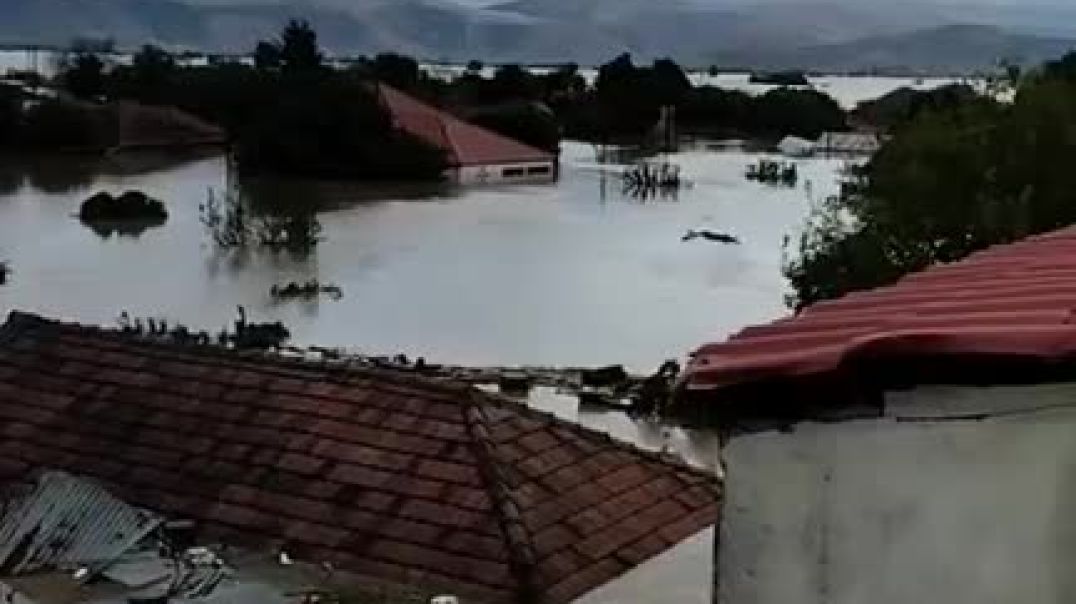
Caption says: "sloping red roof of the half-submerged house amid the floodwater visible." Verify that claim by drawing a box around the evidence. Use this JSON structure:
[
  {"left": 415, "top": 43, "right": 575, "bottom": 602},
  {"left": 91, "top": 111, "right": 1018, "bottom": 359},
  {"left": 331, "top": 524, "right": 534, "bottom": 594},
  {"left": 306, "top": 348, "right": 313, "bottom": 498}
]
[{"left": 378, "top": 84, "right": 556, "bottom": 167}]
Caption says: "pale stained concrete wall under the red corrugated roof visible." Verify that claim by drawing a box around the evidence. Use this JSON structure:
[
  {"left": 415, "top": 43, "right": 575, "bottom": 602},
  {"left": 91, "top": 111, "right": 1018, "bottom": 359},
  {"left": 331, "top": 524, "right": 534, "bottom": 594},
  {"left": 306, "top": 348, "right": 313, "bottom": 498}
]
[{"left": 719, "top": 384, "right": 1076, "bottom": 604}]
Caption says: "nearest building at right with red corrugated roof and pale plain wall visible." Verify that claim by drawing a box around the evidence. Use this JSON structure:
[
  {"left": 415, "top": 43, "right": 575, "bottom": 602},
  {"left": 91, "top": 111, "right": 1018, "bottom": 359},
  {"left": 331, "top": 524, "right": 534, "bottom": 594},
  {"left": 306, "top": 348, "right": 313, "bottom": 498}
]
[{"left": 683, "top": 227, "right": 1076, "bottom": 604}]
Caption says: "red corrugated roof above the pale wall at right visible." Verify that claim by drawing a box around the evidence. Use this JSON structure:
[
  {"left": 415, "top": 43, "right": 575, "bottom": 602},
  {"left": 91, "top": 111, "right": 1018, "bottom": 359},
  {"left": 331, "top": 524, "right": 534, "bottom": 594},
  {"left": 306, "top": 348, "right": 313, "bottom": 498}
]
[{"left": 684, "top": 227, "right": 1076, "bottom": 390}]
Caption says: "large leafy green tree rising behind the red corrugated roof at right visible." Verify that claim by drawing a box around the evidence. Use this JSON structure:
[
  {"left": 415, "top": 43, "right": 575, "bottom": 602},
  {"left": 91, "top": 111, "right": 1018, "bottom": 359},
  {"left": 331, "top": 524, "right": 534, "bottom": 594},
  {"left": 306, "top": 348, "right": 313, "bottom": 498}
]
[{"left": 785, "top": 55, "right": 1076, "bottom": 308}]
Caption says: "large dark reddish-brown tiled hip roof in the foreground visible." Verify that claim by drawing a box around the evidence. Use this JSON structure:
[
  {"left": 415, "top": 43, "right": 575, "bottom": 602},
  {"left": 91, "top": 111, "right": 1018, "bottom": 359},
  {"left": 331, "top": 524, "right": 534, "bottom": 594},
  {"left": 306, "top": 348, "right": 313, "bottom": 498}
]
[{"left": 0, "top": 313, "right": 719, "bottom": 603}]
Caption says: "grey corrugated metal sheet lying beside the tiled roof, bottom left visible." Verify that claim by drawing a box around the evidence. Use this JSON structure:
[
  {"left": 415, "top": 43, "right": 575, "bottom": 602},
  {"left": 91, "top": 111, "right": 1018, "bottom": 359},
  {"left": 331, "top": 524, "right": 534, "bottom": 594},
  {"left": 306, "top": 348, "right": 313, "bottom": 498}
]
[{"left": 0, "top": 472, "right": 160, "bottom": 574}]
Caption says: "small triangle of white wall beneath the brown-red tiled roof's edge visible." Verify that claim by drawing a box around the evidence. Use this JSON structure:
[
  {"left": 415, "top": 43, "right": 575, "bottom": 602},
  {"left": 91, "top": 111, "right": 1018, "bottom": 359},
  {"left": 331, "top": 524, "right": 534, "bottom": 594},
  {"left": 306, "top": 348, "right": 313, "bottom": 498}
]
[{"left": 574, "top": 526, "right": 714, "bottom": 604}]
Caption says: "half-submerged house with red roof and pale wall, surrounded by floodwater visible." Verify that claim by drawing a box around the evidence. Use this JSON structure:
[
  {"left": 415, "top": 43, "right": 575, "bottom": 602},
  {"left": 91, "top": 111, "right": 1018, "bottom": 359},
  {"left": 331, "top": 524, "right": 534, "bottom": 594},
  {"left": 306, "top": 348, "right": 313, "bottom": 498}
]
[{"left": 377, "top": 84, "right": 558, "bottom": 184}]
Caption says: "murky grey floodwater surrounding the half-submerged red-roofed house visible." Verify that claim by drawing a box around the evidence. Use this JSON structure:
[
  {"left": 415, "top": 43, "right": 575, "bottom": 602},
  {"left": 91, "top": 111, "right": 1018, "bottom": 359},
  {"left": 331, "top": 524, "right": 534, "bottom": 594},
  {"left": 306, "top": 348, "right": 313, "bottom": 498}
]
[{"left": 0, "top": 143, "right": 841, "bottom": 371}]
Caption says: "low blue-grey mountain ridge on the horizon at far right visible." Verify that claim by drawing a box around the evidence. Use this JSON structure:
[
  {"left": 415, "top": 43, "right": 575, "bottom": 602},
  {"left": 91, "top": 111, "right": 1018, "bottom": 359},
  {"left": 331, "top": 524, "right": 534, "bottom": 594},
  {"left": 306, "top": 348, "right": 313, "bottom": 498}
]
[{"left": 716, "top": 25, "right": 1076, "bottom": 73}]
